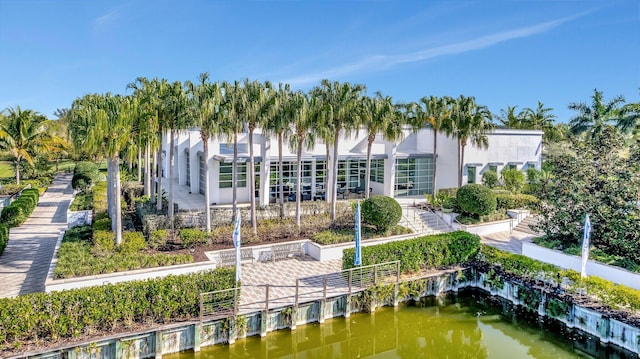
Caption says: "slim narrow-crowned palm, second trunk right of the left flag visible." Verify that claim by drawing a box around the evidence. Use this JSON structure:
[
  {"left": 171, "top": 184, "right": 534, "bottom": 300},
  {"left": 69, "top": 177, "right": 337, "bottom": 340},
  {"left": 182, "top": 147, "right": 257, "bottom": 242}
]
[{"left": 265, "top": 83, "right": 292, "bottom": 219}]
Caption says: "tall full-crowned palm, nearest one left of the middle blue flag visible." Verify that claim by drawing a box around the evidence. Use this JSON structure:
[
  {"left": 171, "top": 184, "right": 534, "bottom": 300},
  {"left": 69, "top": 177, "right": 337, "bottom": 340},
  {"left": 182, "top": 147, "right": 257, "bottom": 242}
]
[{"left": 311, "top": 79, "right": 366, "bottom": 221}]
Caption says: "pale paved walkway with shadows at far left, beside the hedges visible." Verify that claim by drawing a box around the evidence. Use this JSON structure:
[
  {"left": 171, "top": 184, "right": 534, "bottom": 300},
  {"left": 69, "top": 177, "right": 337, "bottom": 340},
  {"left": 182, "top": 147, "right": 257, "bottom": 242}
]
[{"left": 0, "top": 174, "right": 73, "bottom": 298}]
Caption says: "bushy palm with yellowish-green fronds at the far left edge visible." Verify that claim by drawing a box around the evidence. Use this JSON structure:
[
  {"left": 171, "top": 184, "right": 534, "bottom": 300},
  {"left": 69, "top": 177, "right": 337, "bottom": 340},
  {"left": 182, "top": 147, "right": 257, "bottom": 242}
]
[{"left": 0, "top": 107, "right": 62, "bottom": 184}]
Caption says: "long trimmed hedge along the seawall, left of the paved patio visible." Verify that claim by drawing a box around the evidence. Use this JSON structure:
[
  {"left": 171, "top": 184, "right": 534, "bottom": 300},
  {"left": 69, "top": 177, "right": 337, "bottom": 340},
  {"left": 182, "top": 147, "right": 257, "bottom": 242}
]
[{"left": 0, "top": 268, "right": 235, "bottom": 349}]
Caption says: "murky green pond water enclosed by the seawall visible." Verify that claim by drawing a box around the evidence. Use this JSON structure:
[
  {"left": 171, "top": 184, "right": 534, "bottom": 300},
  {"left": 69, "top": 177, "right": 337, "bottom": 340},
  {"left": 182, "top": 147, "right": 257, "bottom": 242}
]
[{"left": 163, "top": 294, "right": 590, "bottom": 359}]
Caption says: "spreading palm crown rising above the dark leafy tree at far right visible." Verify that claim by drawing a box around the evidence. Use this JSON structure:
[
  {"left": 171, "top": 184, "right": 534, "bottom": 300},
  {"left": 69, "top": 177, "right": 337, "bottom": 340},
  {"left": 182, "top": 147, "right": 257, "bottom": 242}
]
[{"left": 569, "top": 89, "right": 625, "bottom": 138}]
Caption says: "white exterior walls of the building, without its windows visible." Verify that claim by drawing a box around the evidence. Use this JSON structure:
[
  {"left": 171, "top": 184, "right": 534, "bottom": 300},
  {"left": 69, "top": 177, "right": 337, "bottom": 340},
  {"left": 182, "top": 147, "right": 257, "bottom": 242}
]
[{"left": 162, "top": 128, "right": 542, "bottom": 205}]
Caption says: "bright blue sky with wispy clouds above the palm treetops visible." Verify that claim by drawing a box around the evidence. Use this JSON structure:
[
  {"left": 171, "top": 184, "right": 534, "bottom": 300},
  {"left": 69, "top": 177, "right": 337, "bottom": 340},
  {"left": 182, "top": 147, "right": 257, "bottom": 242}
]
[{"left": 0, "top": 0, "right": 640, "bottom": 122}]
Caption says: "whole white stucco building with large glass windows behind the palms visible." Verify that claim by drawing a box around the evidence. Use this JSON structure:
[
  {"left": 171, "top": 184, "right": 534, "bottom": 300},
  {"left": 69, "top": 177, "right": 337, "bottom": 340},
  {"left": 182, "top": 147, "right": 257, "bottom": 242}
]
[{"left": 162, "top": 128, "right": 542, "bottom": 205}]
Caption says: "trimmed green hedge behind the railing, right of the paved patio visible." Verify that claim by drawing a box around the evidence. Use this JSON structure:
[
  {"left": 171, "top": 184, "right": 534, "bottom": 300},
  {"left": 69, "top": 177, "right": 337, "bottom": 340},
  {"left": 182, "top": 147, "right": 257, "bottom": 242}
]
[{"left": 342, "top": 231, "right": 480, "bottom": 273}]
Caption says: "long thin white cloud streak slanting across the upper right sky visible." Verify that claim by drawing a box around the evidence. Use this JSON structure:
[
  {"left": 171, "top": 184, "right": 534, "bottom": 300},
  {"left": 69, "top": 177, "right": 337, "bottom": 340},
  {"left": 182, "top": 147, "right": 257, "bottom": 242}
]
[{"left": 284, "top": 13, "right": 585, "bottom": 86}]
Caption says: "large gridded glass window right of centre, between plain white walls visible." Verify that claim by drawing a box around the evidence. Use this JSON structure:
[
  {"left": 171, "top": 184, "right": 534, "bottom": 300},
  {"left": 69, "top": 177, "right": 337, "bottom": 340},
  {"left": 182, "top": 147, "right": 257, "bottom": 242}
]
[{"left": 394, "top": 158, "right": 433, "bottom": 197}]
